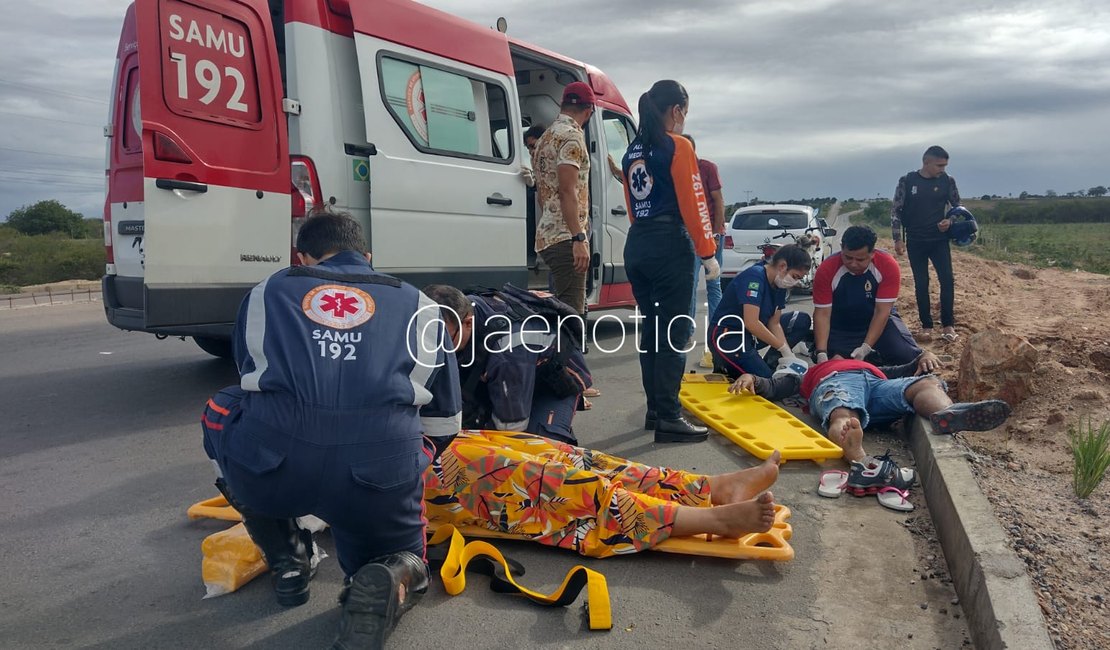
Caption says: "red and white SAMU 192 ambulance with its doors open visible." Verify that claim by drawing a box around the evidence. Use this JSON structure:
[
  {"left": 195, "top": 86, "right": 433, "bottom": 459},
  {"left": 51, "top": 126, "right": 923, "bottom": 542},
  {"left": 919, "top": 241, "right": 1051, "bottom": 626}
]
[{"left": 103, "top": 0, "right": 635, "bottom": 356}]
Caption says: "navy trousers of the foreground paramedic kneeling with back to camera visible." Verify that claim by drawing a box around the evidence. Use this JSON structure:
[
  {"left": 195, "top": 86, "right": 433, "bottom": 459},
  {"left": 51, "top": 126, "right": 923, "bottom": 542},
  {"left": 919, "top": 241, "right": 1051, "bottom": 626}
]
[{"left": 202, "top": 386, "right": 434, "bottom": 576}]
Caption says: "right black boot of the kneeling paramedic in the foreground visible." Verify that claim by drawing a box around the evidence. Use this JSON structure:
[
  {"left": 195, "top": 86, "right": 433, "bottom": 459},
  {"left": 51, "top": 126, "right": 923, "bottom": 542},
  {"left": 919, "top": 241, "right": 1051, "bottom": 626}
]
[{"left": 332, "top": 551, "right": 430, "bottom": 650}]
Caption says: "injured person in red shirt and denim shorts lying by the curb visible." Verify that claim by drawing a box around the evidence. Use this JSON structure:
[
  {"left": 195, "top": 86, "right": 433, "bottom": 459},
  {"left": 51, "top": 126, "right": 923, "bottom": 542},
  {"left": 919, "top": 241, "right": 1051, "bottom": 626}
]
[{"left": 728, "top": 352, "right": 1010, "bottom": 489}]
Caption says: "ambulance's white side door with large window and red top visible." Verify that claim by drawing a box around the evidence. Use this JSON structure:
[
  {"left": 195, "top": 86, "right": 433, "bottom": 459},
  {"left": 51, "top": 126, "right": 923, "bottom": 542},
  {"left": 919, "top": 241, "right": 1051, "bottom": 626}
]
[{"left": 344, "top": 0, "right": 527, "bottom": 286}]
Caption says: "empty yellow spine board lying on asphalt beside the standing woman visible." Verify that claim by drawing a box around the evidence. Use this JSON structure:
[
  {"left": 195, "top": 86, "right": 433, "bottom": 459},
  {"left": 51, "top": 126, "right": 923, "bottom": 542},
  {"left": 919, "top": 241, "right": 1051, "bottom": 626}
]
[{"left": 678, "top": 374, "right": 844, "bottom": 463}]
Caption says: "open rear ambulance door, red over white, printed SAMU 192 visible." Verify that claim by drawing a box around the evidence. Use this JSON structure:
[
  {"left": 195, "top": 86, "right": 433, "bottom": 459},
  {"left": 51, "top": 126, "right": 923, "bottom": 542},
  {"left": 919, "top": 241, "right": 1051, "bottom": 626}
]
[{"left": 135, "top": 0, "right": 291, "bottom": 326}]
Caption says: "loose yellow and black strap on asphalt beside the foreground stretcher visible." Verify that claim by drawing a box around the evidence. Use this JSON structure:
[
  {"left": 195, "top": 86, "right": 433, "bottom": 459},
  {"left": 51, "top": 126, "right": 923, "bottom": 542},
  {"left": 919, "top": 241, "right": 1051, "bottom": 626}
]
[{"left": 428, "top": 524, "right": 613, "bottom": 630}]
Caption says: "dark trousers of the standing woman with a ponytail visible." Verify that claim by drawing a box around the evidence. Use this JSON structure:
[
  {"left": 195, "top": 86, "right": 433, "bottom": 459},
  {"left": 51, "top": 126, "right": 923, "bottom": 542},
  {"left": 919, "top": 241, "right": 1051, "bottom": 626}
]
[{"left": 625, "top": 216, "right": 695, "bottom": 419}]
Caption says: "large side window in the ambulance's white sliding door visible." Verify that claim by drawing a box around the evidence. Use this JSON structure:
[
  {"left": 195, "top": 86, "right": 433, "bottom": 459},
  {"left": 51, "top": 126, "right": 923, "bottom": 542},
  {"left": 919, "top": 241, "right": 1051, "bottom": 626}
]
[{"left": 380, "top": 57, "right": 512, "bottom": 161}]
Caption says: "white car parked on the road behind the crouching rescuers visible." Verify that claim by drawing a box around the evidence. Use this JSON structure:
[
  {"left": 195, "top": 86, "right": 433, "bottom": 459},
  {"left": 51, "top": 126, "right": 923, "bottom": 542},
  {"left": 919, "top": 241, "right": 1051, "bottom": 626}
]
[{"left": 720, "top": 203, "right": 836, "bottom": 291}]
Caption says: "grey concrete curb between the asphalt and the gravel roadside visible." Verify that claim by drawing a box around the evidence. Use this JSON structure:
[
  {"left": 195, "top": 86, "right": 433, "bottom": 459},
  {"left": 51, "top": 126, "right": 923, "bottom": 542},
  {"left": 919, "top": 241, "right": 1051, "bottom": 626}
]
[{"left": 910, "top": 417, "right": 1055, "bottom": 650}]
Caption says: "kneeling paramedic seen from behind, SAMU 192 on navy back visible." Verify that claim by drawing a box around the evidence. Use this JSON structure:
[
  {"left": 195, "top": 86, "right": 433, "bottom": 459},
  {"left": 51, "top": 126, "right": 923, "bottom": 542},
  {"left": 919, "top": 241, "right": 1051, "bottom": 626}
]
[{"left": 203, "top": 213, "right": 462, "bottom": 648}]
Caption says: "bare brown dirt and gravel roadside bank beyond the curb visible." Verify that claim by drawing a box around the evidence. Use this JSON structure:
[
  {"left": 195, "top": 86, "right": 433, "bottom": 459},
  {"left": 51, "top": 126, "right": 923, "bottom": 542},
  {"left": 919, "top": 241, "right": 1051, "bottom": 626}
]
[{"left": 891, "top": 239, "right": 1110, "bottom": 648}]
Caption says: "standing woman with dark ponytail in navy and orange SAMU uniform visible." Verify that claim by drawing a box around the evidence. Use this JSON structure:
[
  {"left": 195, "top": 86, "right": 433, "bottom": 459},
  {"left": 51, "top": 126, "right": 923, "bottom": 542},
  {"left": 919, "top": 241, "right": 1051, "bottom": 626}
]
[{"left": 622, "top": 80, "right": 720, "bottom": 443}]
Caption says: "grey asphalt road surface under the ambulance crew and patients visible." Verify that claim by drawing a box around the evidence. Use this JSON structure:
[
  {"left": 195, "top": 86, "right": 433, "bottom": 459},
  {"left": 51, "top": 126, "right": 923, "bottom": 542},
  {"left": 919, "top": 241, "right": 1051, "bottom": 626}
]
[{"left": 0, "top": 205, "right": 967, "bottom": 649}]
